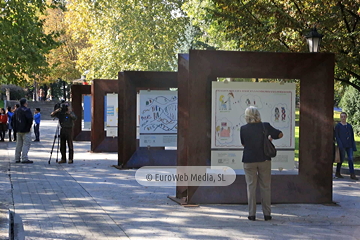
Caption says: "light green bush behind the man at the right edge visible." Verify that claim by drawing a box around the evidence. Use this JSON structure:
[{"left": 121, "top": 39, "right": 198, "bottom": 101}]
[{"left": 340, "top": 87, "right": 360, "bottom": 135}]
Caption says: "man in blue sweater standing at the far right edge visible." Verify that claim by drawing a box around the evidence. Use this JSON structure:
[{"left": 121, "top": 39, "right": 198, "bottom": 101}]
[{"left": 335, "top": 112, "right": 359, "bottom": 180}]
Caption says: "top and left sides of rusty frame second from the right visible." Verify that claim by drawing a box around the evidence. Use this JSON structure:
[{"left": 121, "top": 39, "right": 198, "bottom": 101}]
[{"left": 118, "top": 71, "right": 177, "bottom": 167}]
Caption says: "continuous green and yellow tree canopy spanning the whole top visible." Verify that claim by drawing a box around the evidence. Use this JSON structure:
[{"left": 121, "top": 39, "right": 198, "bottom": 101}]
[{"left": 0, "top": 0, "right": 360, "bottom": 90}]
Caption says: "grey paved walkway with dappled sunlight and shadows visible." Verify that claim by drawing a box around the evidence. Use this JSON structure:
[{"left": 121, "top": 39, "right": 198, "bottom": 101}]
[{"left": 0, "top": 120, "right": 360, "bottom": 239}]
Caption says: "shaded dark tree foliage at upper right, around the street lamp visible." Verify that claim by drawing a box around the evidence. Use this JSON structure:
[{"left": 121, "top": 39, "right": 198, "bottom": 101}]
[{"left": 184, "top": 0, "right": 360, "bottom": 91}]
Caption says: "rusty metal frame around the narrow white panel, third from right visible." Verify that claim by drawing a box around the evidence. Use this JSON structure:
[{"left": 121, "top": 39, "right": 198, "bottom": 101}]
[{"left": 91, "top": 79, "right": 118, "bottom": 152}]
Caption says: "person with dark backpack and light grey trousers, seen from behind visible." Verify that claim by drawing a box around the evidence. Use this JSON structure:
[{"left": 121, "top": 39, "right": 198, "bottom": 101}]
[{"left": 12, "top": 98, "right": 33, "bottom": 163}]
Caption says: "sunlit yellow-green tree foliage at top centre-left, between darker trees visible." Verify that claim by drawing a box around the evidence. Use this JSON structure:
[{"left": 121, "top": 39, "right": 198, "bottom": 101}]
[{"left": 66, "top": 0, "right": 187, "bottom": 78}]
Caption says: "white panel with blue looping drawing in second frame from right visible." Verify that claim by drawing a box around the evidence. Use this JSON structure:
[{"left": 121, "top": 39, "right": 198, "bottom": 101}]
[{"left": 139, "top": 90, "right": 178, "bottom": 147}]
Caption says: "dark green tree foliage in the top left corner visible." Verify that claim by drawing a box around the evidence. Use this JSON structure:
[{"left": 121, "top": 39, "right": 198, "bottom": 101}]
[{"left": 0, "top": 0, "right": 56, "bottom": 85}]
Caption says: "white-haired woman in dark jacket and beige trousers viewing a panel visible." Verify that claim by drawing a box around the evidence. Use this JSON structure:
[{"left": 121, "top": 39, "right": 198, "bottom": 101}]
[{"left": 240, "top": 106, "right": 283, "bottom": 221}]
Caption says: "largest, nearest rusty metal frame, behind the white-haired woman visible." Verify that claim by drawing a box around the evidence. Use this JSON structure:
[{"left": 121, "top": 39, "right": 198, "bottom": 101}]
[{"left": 177, "top": 50, "right": 335, "bottom": 203}]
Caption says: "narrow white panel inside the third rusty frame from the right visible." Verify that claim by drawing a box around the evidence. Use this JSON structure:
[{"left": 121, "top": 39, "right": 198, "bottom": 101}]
[{"left": 106, "top": 93, "right": 118, "bottom": 137}]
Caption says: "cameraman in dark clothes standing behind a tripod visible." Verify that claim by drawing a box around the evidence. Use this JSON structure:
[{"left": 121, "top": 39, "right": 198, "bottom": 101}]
[{"left": 51, "top": 102, "right": 76, "bottom": 164}]
